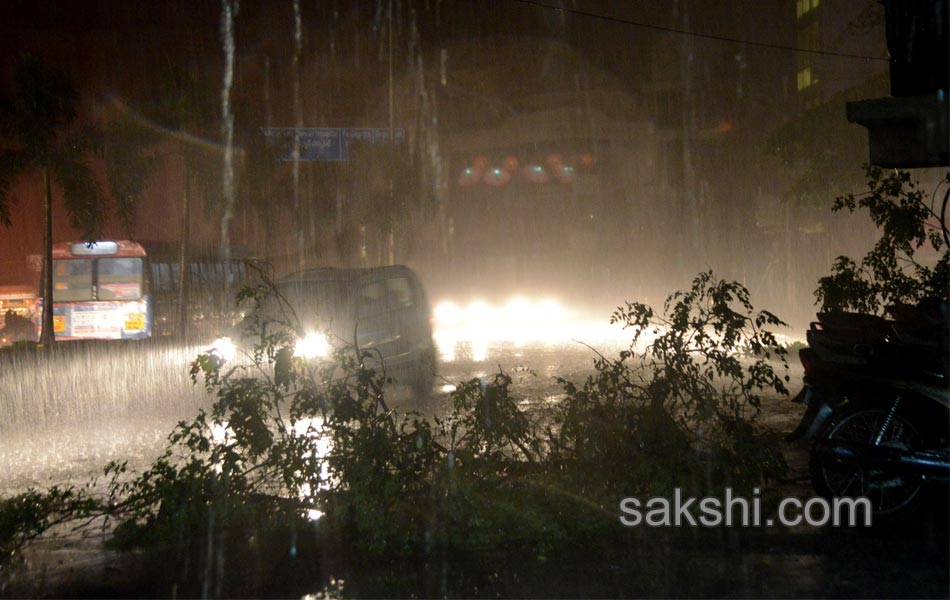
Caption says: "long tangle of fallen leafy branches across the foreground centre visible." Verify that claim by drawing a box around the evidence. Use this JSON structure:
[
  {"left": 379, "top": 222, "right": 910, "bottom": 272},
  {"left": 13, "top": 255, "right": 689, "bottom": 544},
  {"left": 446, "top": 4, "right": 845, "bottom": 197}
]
[{"left": 0, "top": 273, "right": 785, "bottom": 592}]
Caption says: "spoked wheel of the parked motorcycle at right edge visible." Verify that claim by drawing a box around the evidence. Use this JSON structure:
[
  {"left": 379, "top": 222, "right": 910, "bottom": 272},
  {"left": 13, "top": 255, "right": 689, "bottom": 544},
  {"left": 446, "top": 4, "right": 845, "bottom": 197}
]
[{"left": 809, "top": 406, "right": 923, "bottom": 517}]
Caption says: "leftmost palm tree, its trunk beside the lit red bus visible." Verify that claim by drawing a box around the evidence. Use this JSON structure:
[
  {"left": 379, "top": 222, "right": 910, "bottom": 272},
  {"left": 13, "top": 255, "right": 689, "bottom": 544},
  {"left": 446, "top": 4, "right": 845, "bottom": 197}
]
[{"left": 0, "top": 56, "right": 104, "bottom": 347}]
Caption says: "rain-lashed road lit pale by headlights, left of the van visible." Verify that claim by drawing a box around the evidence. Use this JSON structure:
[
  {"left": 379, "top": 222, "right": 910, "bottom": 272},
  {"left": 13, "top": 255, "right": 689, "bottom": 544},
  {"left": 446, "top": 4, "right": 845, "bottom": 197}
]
[{"left": 0, "top": 343, "right": 210, "bottom": 495}]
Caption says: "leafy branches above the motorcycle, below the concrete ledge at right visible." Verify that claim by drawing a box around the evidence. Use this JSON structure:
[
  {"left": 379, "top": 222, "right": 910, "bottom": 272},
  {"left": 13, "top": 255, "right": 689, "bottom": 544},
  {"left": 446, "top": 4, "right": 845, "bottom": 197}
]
[{"left": 815, "top": 166, "right": 950, "bottom": 314}]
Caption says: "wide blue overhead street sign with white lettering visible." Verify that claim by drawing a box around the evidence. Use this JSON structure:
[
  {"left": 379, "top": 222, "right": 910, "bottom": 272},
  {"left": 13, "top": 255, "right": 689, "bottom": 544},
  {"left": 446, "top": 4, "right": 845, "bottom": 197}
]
[{"left": 261, "top": 127, "right": 406, "bottom": 162}]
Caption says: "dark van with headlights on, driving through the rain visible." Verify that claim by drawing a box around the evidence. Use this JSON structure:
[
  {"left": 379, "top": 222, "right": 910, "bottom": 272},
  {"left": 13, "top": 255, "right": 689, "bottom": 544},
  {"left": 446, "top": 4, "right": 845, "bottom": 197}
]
[{"left": 277, "top": 265, "right": 436, "bottom": 395}]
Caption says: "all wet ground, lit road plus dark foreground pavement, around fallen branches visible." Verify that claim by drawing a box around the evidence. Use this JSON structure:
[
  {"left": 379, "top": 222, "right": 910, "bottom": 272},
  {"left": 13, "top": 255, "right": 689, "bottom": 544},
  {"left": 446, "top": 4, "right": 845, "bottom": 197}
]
[{"left": 0, "top": 346, "right": 950, "bottom": 598}]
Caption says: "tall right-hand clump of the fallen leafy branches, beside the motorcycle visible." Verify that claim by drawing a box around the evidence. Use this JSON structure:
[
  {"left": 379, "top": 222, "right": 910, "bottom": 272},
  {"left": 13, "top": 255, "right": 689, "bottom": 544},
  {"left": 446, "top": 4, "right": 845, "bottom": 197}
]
[{"left": 554, "top": 272, "right": 788, "bottom": 496}]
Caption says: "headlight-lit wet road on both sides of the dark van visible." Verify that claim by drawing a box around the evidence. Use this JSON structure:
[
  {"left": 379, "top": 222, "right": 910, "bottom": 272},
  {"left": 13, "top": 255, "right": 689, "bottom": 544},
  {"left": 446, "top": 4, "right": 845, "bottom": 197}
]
[{"left": 0, "top": 343, "right": 632, "bottom": 495}]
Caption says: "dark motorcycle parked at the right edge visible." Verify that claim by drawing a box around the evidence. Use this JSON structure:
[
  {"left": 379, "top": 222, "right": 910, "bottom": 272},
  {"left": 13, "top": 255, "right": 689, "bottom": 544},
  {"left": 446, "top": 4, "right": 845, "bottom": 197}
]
[{"left": 786, "top": 300, "right": 950, "bottom": 516}]
